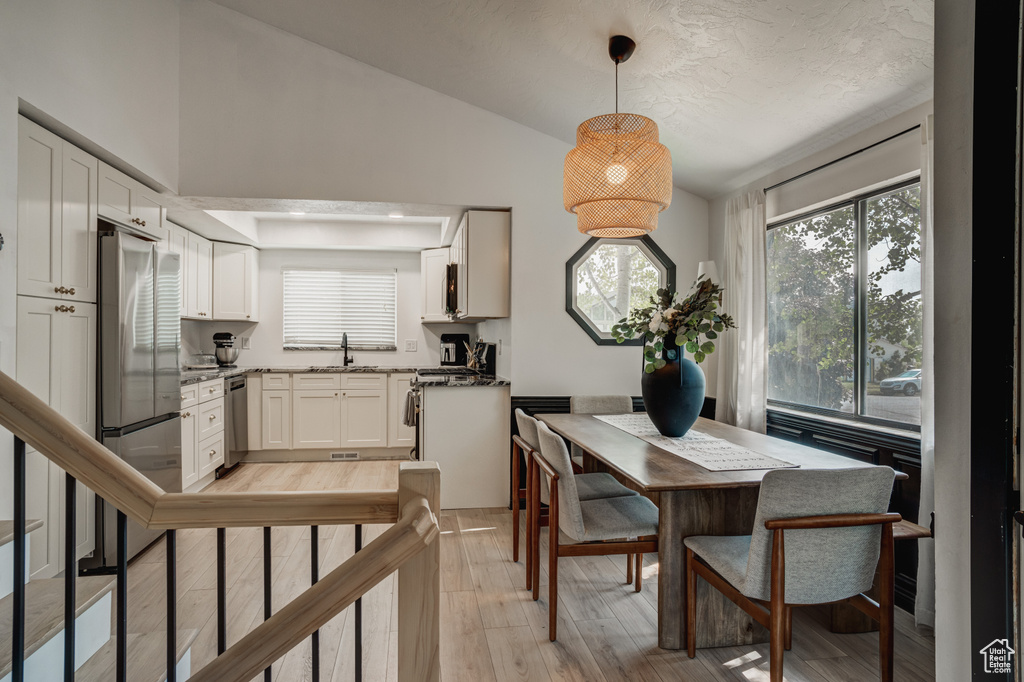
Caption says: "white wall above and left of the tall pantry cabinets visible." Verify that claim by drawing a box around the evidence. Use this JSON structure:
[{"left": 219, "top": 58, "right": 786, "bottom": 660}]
[{"left": 0, "top": 0, "right": 178, "bottom": 517}]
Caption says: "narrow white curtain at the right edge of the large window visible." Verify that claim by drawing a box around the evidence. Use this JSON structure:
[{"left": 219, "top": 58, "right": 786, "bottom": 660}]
[{"left": 914, "top": 116, "right": 935, "bottom": 629}]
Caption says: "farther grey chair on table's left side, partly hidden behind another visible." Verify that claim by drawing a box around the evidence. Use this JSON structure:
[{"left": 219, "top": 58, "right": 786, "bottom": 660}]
[{"left": 512, "top": 409, "right": 637, "bottom": 590}]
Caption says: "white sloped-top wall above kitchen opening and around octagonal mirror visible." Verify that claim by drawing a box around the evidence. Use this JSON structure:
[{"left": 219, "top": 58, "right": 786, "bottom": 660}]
[{"left": 180, "top": 0, "right": 708, "bottom": 395}]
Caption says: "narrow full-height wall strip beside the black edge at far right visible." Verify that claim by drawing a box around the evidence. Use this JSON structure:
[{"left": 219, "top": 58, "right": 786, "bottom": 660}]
[{"left": 935, "top": 0, "right": 970, "bottom": 682}]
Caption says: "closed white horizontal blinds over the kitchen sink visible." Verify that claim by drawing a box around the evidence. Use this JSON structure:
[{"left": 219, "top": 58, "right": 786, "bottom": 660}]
[{"left": 284, "top": 269, "right": 398, "bottom": 350}]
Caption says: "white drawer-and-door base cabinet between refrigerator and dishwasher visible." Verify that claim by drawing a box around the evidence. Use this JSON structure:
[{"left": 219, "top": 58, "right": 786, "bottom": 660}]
[{"left": 181, "top": 379, "right": 225, "bottom": 493}]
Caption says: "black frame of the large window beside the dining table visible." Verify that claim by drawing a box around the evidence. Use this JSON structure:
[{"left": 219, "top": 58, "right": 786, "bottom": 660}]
[{"left": 765, "top": 174, "right": 934, "bottom": 433}]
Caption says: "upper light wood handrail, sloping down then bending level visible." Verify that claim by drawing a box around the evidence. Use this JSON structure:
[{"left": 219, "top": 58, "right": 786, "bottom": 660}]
[{"left": 0, "top": 372, "right": 398, "bottom": 530}]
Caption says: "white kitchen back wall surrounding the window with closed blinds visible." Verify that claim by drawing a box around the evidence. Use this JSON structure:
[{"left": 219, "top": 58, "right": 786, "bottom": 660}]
[{"left": 181, "top": 250, "right": 475, "bottom": 367}]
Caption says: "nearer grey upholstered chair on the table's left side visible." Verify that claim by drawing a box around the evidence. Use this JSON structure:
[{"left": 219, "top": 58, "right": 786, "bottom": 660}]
[{"left": 530, "top": 422, "right": 657, "bottom": 642}]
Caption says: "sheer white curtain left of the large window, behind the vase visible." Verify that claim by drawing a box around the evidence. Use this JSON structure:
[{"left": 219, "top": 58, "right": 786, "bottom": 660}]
[{"left": 715, "top": 189, "right": 768, "bottom": 433}]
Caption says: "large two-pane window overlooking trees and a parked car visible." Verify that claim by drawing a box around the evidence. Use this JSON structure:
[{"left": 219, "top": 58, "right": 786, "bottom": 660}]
[{"left": 767, "top": 183, "right": 931, "bottom": 427}]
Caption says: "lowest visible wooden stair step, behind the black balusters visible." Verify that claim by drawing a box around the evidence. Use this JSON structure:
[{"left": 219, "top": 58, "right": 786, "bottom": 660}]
[{"left": 75, "top": 622, "right": 199, "bottom": 682}]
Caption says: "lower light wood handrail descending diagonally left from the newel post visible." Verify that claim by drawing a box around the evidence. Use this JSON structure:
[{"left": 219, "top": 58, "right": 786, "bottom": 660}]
[{"left": 189, "top": 498, "right": 439, "bottom": 682}]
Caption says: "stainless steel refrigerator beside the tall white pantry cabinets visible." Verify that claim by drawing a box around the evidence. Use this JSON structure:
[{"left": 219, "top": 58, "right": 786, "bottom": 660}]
[{"left": 91, "top": 222, "right": 181, "bottom": 566}]
